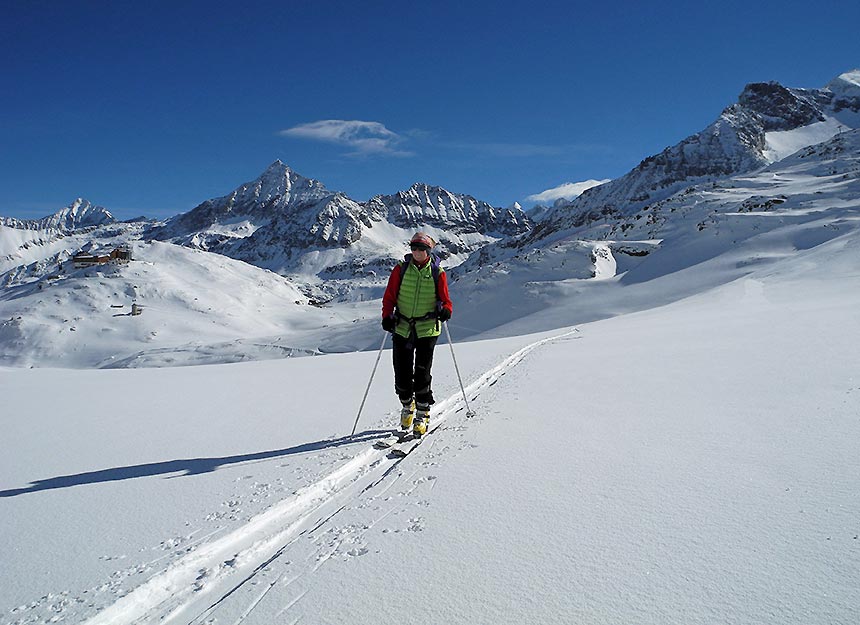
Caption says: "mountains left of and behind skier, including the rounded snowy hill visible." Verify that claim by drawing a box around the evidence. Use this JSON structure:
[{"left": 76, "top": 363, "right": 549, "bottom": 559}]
[{"left": 0, "top": 162, "right": 528, "bottom": 367}]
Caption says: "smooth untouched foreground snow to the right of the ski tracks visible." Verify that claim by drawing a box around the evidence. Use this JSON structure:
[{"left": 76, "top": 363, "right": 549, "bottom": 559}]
[{"left": 290, "top": 266, "right": 860, "bottom": 625}]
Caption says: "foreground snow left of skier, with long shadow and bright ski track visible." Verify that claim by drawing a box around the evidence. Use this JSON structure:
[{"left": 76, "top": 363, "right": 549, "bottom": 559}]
[{"left": 0, "top": 326, "right": 576, "bottom": 622}]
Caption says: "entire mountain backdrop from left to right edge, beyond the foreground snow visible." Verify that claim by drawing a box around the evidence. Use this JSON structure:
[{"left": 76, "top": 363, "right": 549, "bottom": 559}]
[{"left": 0, "top": 71, "right": 860, "bottom": 367}]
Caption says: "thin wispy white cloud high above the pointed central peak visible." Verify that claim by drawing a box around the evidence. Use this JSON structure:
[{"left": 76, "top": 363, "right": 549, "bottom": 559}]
[{"left": 279, "top": 119, "right": 411, "bottom": 156}]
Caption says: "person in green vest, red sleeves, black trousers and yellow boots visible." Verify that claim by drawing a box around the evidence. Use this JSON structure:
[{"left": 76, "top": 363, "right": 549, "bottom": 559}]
[{"left": 382, "top": 232, "right": 454, "bottom": 438}]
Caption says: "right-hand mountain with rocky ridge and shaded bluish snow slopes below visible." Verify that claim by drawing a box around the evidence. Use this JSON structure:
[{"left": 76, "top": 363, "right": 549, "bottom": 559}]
[{"left": 444, "top": 70, "right": 860, "bottom": 336}]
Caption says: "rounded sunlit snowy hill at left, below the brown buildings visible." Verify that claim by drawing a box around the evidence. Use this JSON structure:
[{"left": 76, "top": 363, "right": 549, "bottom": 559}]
[{"left": 0, "top": 242, "right": 333, "bottom": 368}]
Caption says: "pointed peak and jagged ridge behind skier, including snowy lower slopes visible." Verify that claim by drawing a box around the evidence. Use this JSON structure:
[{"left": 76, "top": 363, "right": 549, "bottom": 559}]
[{"left": 153, "top": 161, "right": 531, "bottom": 301}]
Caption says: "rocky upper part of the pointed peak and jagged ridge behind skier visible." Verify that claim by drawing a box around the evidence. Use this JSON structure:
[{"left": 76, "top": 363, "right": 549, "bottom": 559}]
[{"left": 153, "top": 161, "right": 529, "bottom": 258}]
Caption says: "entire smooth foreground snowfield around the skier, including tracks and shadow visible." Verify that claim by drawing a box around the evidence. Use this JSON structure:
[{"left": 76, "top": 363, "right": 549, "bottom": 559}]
[{"left": 0, "top": 225, "right": 860, "bottom": 624}]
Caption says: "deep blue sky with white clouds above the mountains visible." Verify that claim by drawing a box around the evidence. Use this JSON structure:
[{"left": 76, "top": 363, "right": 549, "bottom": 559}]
[{"left": 0, "top": 0, "right": 860, "bottom": 218}]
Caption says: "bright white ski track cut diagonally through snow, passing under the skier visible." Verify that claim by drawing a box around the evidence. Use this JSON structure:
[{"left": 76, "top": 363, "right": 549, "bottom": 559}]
[{"left": 75, "top": 328, "right": 579, "bottom": 625}]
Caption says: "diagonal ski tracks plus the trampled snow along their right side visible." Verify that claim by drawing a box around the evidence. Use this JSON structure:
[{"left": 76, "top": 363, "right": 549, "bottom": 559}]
[{"left": 74, "top": 329, "right": 578, "bottom": 625}]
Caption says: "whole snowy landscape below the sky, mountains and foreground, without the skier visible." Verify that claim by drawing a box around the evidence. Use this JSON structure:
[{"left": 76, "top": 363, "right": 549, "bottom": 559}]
[{"left": 5, "top": 70, "right": 860, "bottom": 625}]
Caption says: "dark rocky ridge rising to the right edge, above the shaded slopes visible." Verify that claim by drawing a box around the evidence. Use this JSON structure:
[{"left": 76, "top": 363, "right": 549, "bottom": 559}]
[{"left": 527, "top": 70, "right": 860, "bottom": 236}]
